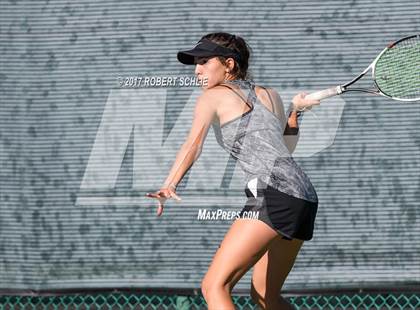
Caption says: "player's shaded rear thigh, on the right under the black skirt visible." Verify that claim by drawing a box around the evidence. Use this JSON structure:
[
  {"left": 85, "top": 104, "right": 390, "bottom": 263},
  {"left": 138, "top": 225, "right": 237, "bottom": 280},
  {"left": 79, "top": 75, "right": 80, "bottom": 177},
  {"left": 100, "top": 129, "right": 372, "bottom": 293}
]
[{"left": 251, "top": 236, "right": 303, "bottom": 298}]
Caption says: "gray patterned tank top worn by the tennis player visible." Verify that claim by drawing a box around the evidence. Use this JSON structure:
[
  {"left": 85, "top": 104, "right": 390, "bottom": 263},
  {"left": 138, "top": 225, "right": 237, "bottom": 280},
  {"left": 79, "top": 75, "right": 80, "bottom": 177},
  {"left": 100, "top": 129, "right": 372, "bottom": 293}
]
[{"left": 212, "top": 80, "right": 318, "bottom": 203}]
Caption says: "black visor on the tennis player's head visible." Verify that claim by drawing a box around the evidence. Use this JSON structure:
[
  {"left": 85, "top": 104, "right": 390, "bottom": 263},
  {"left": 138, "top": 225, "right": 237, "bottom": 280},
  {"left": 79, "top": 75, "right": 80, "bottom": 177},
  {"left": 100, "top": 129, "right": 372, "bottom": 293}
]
[{"left": 177, "top": 39, "right": 240, "bottom": 65}]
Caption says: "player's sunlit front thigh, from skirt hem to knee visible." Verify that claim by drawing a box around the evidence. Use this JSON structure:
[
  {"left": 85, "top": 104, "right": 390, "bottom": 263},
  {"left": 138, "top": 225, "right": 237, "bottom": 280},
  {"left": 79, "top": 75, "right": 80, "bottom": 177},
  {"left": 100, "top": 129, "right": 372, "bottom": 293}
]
[{"left": 203, "top": 219, "right": 277, "bottom": 290}]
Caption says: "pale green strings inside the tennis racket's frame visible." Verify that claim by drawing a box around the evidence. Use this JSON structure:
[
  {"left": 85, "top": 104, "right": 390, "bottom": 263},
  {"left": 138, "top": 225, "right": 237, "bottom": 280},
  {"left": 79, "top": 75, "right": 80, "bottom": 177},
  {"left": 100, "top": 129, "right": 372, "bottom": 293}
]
[{"left": 375, "top": 36, "right": 420, "bottom": 100}]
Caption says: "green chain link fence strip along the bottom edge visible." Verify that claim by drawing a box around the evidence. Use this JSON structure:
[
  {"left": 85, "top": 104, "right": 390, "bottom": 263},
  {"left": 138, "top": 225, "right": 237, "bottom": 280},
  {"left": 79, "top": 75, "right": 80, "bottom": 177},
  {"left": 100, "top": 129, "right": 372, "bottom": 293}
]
[{"left": 0, "top": 293, "right": 420, "bottom": 310}]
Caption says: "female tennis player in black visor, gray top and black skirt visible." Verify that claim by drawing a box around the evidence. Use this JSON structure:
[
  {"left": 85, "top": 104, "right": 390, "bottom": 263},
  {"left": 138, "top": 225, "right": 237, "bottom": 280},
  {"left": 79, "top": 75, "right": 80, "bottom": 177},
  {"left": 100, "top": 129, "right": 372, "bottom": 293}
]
[{"left": 146, "top": 32, "right": 319, "bottom": 310}]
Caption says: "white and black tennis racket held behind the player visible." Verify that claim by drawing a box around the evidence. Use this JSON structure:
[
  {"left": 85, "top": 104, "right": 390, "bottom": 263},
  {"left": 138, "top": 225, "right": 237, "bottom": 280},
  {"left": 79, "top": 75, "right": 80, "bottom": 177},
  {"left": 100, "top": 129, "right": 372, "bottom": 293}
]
[{"left": 306, "top": 34, "right": 420, "bottom": 101}]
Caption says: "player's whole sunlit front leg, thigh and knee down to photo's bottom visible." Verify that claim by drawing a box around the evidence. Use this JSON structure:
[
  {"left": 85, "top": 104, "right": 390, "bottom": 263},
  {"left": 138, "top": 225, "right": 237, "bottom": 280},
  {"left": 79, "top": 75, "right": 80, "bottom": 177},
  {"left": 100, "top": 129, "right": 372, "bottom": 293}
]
[{"left": 201, "top": 219, "right": 277, "bottom": 310}]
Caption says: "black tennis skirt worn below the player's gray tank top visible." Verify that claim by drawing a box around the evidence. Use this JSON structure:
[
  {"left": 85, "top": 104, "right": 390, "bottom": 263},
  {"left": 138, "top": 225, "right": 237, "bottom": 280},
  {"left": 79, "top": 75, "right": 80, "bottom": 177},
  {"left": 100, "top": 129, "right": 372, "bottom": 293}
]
[{"left": 240, "top": 180, "right": 318, "bottom": 240}]
